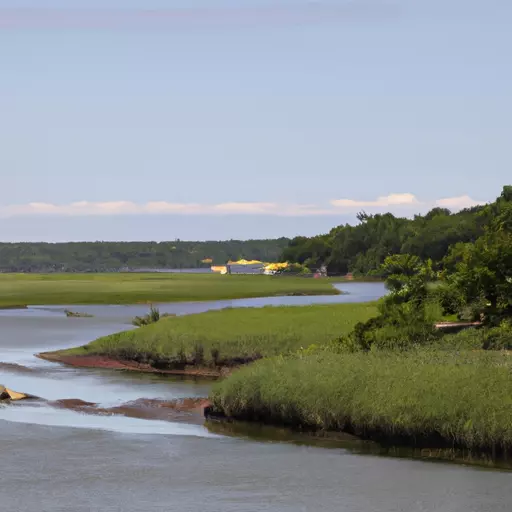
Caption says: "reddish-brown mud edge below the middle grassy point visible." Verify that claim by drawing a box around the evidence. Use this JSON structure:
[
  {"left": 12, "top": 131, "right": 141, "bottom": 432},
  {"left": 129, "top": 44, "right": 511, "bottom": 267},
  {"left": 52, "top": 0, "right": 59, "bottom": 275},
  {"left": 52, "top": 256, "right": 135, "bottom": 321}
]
[{"left": 37, "top": 352, "right": 233, "bottom": 377}]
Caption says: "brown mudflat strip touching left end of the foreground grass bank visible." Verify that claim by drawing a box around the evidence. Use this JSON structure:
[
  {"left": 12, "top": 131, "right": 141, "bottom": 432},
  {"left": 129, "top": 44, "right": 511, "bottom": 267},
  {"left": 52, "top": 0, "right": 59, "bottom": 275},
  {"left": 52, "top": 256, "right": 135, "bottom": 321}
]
[{"left": 49, "top": 398, "right": 210, "bottom": 424}]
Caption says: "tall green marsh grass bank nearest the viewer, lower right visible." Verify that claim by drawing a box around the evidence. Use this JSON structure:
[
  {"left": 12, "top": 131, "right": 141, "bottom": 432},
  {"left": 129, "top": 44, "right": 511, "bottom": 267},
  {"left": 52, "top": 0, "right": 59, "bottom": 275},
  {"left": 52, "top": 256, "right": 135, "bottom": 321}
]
[{"left": 211, "top": 351, "right": 512, "bottom": 451}]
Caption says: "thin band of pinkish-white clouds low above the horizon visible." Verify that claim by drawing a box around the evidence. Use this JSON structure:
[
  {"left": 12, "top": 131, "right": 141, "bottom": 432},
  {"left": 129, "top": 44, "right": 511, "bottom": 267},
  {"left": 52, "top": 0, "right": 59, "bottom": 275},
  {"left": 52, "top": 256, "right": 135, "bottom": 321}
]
[{"left": 0, "top": 193, "right": 484, "bottom": 218}]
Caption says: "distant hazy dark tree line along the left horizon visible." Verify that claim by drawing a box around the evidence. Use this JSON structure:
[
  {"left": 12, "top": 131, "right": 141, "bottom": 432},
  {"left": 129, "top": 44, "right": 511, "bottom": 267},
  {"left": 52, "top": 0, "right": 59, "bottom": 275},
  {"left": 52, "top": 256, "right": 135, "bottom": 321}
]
[{"left": 0, "top": 238, "right": 289, "bottom": 272}]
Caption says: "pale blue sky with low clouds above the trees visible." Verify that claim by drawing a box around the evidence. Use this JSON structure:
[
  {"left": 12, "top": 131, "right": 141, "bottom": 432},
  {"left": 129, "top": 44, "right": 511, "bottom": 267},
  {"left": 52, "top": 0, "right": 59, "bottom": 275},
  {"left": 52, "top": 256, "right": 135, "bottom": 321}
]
[{"left": 0, "top": 0, "right": 512, "bottom": 241}]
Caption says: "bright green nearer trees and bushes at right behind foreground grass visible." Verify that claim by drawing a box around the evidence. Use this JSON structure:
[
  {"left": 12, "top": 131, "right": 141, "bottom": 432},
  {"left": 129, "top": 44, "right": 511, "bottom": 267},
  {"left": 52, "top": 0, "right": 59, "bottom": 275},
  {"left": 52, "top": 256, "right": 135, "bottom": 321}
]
[{"left": 330, "top": 187, "right": 512, "bottom": 351}]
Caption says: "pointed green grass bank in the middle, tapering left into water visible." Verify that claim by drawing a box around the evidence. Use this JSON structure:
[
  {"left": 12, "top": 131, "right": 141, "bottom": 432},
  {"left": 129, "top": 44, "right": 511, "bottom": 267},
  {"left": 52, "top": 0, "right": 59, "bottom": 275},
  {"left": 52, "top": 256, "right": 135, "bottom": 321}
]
[{"left": 43, "top": 303, "right": 376, "bottom": 368}]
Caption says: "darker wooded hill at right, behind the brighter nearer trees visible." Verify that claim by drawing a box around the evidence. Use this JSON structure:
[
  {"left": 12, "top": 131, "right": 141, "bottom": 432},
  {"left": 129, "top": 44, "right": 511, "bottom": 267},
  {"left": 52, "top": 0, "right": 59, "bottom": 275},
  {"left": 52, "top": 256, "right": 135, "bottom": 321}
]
[{"left": 281, "top": 186, "right": 512, "bottom": 276}]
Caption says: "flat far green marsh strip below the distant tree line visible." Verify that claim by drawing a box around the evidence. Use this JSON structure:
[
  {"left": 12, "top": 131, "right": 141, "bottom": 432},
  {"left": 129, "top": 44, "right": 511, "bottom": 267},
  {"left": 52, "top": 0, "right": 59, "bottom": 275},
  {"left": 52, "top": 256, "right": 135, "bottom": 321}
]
[{"left": 0, "top": 273, "right": 337, "bottom": 307}]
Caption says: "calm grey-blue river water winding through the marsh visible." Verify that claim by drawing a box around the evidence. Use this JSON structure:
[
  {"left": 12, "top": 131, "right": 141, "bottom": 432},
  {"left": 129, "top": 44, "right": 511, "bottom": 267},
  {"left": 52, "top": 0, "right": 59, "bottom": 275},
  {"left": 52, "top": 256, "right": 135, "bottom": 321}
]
[{"left": 0, "top": 283, "right": 512, "bottom": 512}]
